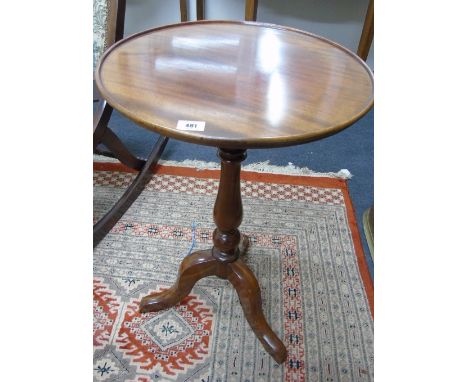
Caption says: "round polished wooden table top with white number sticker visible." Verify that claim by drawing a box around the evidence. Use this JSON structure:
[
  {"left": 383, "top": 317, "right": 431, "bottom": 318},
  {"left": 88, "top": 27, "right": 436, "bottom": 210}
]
[{"left": 96, "top": 21, "right": 374, "bottom": 148}]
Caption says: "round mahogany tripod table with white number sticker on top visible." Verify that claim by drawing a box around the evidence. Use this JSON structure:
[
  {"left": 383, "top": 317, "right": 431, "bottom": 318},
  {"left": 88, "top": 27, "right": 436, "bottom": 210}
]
[{"left": 96, "top": 21, "right": 373, "bottom": 363}]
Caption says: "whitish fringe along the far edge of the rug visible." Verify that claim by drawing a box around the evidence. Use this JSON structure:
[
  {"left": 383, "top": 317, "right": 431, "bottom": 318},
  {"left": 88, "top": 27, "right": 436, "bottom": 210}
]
[{"left": 93, "top": 154, "right": 352, "bottom": 179}]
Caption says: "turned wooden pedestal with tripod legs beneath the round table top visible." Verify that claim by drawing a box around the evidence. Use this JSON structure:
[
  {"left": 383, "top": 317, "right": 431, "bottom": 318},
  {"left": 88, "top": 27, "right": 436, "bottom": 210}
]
[{"left": 140, "top": 149, "right": 287, "bottom": 363}]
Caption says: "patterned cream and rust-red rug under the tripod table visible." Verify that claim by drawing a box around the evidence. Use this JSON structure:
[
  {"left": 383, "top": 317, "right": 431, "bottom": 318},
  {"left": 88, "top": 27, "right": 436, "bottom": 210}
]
[{"left": 93, "top": 163, "right": 373, "bottom": 382}]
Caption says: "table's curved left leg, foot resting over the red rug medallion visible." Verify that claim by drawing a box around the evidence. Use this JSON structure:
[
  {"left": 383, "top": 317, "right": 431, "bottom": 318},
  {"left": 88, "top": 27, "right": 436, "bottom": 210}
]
[{"left": 140, "top": 249, "right": 218, "bottom": 313}]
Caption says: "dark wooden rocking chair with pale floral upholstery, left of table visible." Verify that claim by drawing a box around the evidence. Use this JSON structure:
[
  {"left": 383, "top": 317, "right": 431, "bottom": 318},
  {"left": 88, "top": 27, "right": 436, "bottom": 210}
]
[{"left": 93, "top": 0, "right": 168, "bottom": 247}]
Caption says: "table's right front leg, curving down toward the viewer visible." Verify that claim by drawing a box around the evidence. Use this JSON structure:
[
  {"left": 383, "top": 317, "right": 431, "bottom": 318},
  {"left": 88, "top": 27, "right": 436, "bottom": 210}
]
[{"left": 227, "top": 259, "right": 287, "bottom": 364}]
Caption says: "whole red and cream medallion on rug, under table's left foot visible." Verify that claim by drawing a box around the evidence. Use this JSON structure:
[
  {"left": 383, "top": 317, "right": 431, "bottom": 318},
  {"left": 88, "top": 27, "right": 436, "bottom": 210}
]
[{"left": 116, "top": 293, "right": 213, "bottom": 378}]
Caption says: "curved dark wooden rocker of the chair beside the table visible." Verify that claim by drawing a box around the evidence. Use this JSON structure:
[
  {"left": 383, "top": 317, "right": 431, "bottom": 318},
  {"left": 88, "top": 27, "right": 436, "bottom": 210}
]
[{"left": 93, "top": 136, "right": 169, "bottom": 247}]
